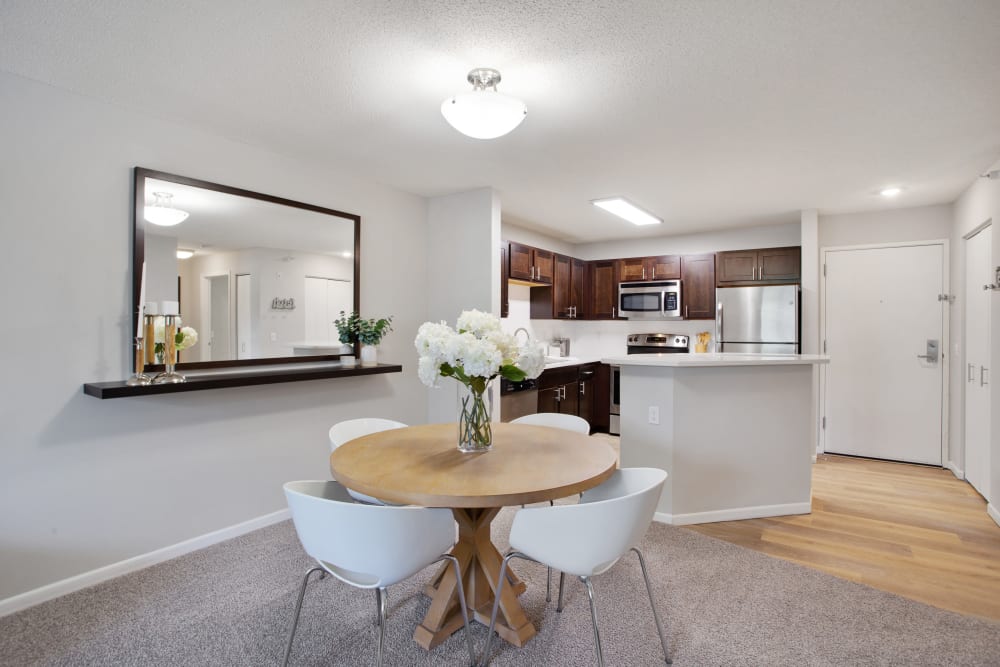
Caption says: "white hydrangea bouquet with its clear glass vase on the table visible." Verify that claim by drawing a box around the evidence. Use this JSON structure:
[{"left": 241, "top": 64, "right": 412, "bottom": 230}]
[{"left": 414, "top": 310, "right": 545, "bottom": 452}]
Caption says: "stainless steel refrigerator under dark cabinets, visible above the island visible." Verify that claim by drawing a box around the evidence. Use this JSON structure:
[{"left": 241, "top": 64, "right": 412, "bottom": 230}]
[{"left": 715, "top": 285, "right": 801, "bottom": 354}]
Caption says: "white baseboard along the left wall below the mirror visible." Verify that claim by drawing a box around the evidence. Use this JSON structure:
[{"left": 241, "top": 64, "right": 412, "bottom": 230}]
[{"left": 0, "top": 509, "right": 291, "bottom": 616}]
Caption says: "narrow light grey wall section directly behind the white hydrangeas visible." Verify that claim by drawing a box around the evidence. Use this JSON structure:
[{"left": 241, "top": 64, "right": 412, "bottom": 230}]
[{"left": 426, "top": 188, "right": 500, "bottom": 423}]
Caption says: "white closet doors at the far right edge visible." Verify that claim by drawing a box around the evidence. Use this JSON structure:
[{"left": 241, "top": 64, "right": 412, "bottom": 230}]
[{"left": 965, "top": 226, "right": 994, "bottom": 500}]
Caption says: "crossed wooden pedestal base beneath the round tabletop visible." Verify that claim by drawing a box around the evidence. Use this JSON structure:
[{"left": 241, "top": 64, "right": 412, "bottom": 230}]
[{"left": 413, "top": 507, "right": 536, "bottom": 650}]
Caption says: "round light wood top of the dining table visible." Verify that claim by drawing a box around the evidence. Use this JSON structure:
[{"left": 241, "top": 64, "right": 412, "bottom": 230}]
[{"left": 330, "top": 423, "right": 617, "bottom": 508}]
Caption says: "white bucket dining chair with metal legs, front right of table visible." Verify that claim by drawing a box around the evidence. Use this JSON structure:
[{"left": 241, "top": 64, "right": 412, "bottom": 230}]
[{"left": 480, "top": 468, "right": 670, "bottom": 667}]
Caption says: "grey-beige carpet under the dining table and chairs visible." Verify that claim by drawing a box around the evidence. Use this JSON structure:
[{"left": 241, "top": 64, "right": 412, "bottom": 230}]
[{"left": 0, "top": 509, "right": 1000, "bottom": 667}]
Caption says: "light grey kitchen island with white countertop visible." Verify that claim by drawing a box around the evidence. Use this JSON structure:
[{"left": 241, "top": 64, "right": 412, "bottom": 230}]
[{"left": 601, "top": 354, "right": 829, "bottom": 525}]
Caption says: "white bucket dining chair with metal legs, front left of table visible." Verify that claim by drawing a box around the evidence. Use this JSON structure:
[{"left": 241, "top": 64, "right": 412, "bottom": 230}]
[{"left": 284, "top": 481, "right": 476, "bottom": 665}]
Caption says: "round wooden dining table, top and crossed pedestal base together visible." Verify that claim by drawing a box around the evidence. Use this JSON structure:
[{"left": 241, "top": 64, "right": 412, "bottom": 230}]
[{"left": 330, "top": 423, "right": 617, "bottom": 649}]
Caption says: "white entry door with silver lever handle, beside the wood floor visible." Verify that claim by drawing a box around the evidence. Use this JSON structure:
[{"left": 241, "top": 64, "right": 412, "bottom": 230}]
[{"left": 822, "top": 242, "right": 947, "bottom": 465}]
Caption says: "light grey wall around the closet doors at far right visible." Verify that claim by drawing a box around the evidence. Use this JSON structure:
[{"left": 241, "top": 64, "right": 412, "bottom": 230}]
[{"left": 950, "top": 161, "right": 1000, "bottom": 512}]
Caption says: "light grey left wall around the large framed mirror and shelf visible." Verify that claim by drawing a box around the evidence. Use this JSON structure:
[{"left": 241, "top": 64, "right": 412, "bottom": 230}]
[{"left": 0, "top": 73, "right": 426, "bottom": 600}]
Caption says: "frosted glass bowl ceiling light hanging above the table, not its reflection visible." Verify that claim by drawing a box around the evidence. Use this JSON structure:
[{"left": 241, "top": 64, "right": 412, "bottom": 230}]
[{"left": 441, "top": 67, "right": 528, "bottom": 139}]
